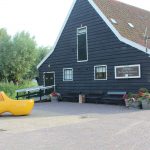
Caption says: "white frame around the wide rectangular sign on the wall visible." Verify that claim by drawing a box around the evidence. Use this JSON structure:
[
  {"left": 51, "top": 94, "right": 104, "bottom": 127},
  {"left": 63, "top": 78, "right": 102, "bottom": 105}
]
[{"left": 114, "top": 64, "right": 141, "bottom": 79}]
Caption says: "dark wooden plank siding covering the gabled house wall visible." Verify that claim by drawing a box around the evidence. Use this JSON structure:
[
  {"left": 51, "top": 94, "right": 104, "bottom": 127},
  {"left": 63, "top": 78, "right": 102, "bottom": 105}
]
[{"left": 39, "top": 0, "right": 150, "bottom": 93}]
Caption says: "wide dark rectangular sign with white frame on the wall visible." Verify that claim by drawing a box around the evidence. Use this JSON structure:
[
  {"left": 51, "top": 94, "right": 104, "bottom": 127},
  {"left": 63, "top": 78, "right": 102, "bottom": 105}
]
[{"left": 115, "top": 64, "right": 141, "bottom": 79}]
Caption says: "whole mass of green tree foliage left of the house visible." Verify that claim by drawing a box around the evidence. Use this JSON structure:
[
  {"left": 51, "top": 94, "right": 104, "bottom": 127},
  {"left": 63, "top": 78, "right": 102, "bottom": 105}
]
[{"left": 0, "top": 29, "right": 49, "bottom": 83}]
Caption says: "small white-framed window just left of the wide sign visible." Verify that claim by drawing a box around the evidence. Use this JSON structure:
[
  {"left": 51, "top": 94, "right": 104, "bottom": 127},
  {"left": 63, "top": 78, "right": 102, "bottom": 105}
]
[{"left": 94, "top": 65, "right": 107, "bottom": 80}]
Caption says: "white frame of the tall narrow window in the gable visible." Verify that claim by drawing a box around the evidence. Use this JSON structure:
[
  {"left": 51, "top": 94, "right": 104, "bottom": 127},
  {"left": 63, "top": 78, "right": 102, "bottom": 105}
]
[{"left": 77, "top": 26, "right": 88, "bottom": 62}]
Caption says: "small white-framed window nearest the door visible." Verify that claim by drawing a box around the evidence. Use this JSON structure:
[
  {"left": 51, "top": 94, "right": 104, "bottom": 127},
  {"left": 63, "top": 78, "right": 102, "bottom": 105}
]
[{"left": 63, "top": 68, "right": 73, "bottom": 81}]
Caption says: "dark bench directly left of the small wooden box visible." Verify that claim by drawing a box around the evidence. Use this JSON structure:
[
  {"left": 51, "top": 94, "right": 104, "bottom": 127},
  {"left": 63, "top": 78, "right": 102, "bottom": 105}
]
[{"left": 61, "top": 92, "right": 79, "bottom": 102}]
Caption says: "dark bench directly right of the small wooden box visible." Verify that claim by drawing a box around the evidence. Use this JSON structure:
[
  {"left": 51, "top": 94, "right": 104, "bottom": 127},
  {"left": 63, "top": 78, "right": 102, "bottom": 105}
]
[{"left": 85, "top": 91, "right": 103, "bottom": 103}]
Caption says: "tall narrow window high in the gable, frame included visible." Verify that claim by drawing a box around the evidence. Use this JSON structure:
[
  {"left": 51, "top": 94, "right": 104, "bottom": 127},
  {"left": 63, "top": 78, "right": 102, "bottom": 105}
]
[{"left": 77, "top": 27, "right": 88, "bottom": 62}]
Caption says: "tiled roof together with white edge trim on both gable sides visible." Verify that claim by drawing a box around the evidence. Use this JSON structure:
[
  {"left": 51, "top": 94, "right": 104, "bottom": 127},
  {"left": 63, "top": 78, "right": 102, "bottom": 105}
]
[{"left": 37, "top": 0, "right": 150, "bottom": 68}]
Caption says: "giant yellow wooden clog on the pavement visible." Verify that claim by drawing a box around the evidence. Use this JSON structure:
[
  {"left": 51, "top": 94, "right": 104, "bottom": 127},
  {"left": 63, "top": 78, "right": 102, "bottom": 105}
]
[{"left": 0, "top": 92, "right": 34, "bottom": 116}]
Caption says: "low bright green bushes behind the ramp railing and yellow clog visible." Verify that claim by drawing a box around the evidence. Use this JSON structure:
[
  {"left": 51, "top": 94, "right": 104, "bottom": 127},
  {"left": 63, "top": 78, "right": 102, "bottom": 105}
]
[{"left": 0, "top": 80, "right": 37, "bottom": 99}]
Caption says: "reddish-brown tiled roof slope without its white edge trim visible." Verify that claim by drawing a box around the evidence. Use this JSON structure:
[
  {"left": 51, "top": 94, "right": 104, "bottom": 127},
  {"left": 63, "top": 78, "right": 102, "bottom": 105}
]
[{"left": 93, "top": 0, "right": 150, "bottom": 48}]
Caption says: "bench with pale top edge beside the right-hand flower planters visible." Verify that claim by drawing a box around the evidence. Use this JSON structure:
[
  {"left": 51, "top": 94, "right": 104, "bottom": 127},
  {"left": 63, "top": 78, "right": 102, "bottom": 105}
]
[{"left": 102, "top": 91, "right": 127, "bottom": 105}]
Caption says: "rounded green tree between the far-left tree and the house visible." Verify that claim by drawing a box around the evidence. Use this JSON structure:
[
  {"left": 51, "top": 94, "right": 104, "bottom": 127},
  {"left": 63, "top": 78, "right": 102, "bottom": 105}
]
[{"left": 7, "top": 31, "right": 37, "bottom": 83}]
